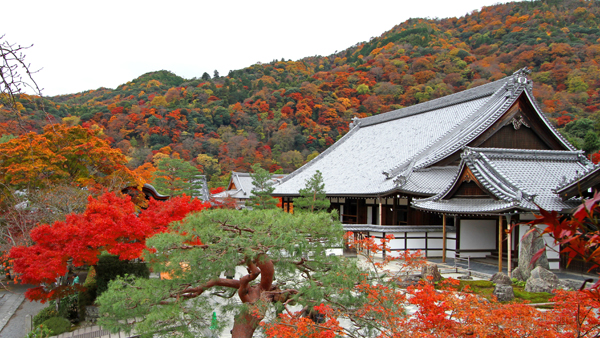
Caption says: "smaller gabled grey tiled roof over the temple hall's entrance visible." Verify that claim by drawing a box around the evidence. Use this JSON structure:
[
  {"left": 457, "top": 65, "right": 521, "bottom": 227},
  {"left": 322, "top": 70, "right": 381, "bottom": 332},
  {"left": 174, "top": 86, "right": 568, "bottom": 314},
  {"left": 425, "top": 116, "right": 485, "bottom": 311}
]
[{"left": 413, "top": 147, "right": 593, "bottom": 214}]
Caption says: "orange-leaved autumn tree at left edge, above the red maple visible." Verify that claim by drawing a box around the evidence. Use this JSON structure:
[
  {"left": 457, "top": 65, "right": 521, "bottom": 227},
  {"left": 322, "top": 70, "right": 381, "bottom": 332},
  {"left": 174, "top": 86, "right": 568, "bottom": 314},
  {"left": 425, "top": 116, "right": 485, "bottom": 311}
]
[{"left": 0, "top": 124, "right": 140, "bottom": 193}]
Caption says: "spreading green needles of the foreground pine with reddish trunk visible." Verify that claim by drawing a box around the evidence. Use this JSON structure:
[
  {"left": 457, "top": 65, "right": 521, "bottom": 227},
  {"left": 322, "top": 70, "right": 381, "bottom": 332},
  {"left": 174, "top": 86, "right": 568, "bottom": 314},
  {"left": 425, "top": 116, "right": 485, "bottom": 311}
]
[{"left": 97, "top": 209, "right": 366, "bottom": 337}]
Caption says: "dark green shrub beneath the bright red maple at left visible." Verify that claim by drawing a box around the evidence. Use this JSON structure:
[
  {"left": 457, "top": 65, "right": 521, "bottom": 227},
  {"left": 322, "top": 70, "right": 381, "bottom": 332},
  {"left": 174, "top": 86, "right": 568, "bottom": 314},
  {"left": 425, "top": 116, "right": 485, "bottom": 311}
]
[{"left": 95, "top": 254, "right": 150, "bottom": 296}]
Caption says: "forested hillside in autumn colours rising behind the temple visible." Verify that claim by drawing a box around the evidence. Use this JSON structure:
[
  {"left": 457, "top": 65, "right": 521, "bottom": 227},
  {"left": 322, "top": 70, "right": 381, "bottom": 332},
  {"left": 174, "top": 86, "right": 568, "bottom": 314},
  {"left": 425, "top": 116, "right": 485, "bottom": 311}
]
[{"left": 0, "top": 0, "right": 600, "bottom": 186}]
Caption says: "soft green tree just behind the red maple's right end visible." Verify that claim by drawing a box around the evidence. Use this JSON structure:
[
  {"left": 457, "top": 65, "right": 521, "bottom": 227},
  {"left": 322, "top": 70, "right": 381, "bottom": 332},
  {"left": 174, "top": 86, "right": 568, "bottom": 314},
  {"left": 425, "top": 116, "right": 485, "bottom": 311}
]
[{"left": 152, "top": 157, "right": 203, "bottom": 197}]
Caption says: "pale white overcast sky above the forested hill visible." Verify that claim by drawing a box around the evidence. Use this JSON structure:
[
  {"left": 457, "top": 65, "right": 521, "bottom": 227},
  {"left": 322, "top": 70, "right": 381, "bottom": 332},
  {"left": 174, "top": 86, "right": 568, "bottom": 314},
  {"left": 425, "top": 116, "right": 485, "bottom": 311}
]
[{"left": 0, "top": 0, "right": 520, "bottom": 96}]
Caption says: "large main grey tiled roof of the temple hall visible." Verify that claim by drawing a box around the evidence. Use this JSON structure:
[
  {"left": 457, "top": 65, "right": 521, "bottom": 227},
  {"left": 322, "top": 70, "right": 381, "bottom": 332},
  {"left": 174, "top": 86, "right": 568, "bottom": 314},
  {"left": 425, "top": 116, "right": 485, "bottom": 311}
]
[{"left": 274, "top": 70, "right": 574, "bottom": 196}]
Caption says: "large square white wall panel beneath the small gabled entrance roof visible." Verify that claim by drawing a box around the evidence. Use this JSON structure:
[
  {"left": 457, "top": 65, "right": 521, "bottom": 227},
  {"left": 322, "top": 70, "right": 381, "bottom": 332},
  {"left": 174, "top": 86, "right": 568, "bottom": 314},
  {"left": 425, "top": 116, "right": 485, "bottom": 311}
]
[{"left": 460, "top": 219, "right": 497, "bottom": 257}]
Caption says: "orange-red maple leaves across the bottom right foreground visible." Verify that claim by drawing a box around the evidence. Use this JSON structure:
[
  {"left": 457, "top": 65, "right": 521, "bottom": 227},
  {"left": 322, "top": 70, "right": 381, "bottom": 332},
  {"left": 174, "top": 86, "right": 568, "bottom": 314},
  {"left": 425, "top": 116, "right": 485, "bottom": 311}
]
[{"left": 265, "top": 228, "right": 600, "bottom": 338}]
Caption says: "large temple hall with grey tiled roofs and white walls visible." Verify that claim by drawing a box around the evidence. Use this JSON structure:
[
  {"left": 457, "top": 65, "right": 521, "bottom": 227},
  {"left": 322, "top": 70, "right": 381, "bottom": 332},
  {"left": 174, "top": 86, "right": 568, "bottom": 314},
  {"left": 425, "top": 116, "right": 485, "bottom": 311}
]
[{"left": 273, "top": 69, "right": 600, "bottom": 268}]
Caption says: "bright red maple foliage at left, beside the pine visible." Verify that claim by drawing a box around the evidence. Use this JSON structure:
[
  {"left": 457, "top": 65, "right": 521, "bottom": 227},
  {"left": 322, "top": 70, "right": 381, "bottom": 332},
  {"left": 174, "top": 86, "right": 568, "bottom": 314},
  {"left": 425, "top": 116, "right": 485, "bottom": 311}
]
[{"left": 10, "top": 193, "right": 209, "bottom": 300}]
